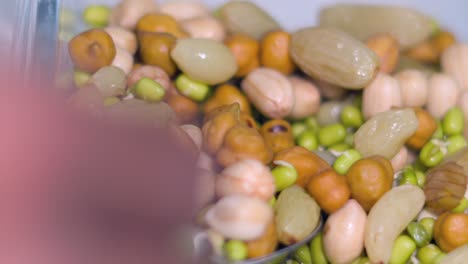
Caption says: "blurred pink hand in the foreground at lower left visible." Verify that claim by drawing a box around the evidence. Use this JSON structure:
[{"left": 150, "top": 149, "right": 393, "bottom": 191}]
[{"left": 0, "top": 72, "right": 195, "bottom": 264}]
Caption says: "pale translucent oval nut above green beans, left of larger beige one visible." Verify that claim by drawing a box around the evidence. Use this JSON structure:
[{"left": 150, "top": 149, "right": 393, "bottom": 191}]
[{"left": 171, "top": 39, "right": 237, "bottom": 85}]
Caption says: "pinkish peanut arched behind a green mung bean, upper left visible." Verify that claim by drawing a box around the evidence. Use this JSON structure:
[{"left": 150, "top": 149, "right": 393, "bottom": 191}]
[{"left": 127, "top": 65, "right": 171, "bottom": 94}]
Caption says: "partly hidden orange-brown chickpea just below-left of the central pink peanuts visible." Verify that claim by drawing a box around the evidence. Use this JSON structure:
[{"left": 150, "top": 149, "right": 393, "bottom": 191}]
[{"left": 203, "top": 84, "right": 251, "bottom": 115}]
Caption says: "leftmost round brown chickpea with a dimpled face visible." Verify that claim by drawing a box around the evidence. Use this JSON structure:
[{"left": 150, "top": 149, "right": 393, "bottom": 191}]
[{"left": 68, "top": 29, "right": 116, "bottom": 73}]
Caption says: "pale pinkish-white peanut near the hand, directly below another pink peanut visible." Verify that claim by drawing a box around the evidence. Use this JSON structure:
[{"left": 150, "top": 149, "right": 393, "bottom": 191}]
[{"left": 206, "top": 195, "right": 273, "bottom": 241}]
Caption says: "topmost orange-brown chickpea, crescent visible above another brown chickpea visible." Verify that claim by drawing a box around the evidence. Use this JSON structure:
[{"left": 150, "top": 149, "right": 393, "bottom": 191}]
[{"left": 136, "top": 13, "right": 188, "bottom": 38}]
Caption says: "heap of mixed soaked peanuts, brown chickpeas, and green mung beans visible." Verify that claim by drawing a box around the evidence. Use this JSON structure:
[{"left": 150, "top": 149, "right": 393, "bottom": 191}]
[{"left": 63, "top": 0, "right": 468, "bottom": 264}]
